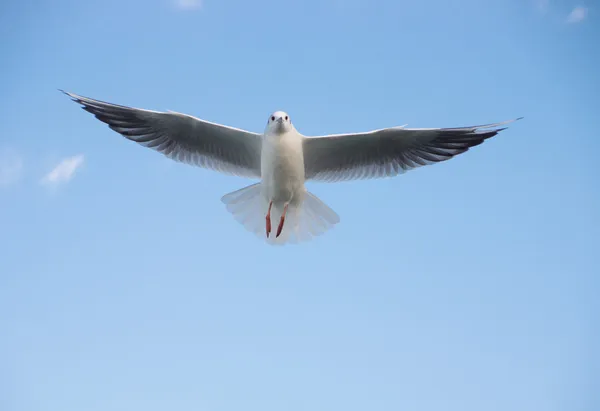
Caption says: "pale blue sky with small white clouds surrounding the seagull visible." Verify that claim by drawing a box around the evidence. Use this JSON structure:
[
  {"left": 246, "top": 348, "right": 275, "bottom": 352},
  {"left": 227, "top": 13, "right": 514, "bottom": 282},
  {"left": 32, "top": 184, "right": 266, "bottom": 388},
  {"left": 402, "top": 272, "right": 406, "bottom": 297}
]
[{"left": 0, "top": 0, "right": 600, "bottom": 411}]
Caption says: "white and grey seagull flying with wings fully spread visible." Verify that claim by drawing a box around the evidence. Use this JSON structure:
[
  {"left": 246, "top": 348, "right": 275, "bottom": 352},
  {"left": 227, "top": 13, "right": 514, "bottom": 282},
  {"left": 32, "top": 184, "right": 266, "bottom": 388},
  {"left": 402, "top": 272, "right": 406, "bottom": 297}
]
[{"left": 60, "top": 90, "right": 522, "bottom": 244}]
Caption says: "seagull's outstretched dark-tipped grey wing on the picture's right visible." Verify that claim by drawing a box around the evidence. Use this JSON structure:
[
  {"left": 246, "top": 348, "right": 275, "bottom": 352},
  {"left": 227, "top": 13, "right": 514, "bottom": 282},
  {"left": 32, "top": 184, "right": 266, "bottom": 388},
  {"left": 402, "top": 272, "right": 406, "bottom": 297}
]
[{"left": 303, "top": 118, "right": 520, "bottom": 182}]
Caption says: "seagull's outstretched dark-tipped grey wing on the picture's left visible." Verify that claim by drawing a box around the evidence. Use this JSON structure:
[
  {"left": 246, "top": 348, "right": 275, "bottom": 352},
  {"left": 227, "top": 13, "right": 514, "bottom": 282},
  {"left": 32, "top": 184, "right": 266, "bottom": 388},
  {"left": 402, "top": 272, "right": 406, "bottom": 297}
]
[{"left": 61, "top": 90, "right": 262, "bottom": 178}]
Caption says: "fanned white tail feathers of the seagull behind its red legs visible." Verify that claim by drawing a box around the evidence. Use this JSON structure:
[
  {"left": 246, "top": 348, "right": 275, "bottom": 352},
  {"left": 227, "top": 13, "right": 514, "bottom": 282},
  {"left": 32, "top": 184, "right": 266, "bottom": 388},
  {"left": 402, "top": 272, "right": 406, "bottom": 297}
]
[{"left": 221, "top": 183, "right": 340, "bottom": 245}]
